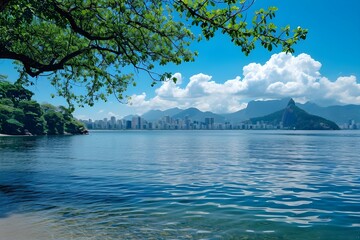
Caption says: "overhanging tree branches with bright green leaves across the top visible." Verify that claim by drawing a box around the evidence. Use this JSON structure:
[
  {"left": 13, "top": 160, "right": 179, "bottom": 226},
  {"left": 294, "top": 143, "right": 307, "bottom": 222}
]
[{"left": 0, "top": 0, "right": 307, "bottom": 109}]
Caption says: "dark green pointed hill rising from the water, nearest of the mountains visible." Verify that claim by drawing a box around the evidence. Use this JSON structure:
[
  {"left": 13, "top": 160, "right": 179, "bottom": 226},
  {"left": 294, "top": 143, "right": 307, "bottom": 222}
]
[{"left": 250, "top": 99, "right": 340, "bottom": 130}]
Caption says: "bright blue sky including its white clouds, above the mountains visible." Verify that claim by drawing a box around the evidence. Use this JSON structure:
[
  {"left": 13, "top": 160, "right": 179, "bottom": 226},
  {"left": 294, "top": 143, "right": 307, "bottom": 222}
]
[{"left": 0, "top": 0, "right": 360, "bottom": 119}]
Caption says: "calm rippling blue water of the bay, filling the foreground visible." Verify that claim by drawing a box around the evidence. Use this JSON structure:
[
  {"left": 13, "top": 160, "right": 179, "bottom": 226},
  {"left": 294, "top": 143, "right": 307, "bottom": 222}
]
[{"left": 0, "top": 131, "right": 360, "bottom": 240}]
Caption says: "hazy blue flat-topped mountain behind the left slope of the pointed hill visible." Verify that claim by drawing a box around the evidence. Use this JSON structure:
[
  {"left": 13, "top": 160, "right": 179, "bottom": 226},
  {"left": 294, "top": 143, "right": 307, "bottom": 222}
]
[{"left": 223, "top": 98, "right": 290, "bottom": 123}]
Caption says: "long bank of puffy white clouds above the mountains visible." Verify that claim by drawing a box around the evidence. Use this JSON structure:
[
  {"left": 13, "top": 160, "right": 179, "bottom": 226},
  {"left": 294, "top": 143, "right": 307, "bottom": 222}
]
[{"left": 131, "top": 53, "right": 360, "bottom": 113}]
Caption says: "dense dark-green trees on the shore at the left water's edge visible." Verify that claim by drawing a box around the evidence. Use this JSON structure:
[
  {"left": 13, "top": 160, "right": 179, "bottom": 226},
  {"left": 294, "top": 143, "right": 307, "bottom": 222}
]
[{"left": 0, "top": 80, "right": 86, "bottom": 135}]
